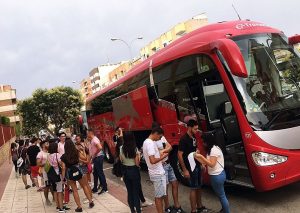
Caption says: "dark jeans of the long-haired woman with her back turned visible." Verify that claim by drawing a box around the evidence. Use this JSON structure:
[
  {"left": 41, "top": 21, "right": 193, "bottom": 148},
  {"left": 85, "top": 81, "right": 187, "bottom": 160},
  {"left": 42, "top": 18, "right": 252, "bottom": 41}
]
[{"left": 124, "top": 166, "right": 141, "bottom": 213}]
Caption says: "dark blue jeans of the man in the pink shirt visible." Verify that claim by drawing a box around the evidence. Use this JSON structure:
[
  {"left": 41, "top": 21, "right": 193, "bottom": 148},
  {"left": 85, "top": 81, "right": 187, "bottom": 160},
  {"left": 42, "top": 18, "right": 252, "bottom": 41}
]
[{"left": 93, "top": 155, "right": 107, "bottom": 191}]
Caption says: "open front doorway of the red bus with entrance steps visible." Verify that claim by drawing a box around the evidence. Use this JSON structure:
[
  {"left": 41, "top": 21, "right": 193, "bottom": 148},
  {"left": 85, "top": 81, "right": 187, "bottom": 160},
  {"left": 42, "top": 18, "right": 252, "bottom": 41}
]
[{"left": 197, "top": 55, "right": 253, "bottom": 188}]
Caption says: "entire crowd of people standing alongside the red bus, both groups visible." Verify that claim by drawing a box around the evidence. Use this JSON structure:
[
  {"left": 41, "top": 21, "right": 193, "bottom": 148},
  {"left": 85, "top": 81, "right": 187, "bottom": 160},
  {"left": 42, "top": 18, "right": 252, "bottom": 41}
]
[{"left": 11, "top": 119, "right": 230, "bottom": 213}]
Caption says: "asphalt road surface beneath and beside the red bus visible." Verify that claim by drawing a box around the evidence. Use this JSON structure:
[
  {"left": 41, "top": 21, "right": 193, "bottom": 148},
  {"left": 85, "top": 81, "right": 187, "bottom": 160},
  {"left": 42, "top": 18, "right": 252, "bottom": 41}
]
[{"left": 104, "top": 163, "right": 300, "bottom": 213}]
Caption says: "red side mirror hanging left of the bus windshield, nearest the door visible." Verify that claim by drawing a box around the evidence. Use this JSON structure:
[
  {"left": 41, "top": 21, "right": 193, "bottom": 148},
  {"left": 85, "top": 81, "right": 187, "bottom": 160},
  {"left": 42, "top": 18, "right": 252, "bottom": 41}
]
[{"left": 212, "top": 39, "right": 248, "bottom": 78}]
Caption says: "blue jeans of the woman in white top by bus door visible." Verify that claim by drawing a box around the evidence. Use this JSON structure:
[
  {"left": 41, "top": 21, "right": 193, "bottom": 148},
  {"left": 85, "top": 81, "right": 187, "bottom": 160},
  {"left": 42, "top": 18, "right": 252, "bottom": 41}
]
[{"left": 210, "top": 170, "right": 230, "bottom": 213}]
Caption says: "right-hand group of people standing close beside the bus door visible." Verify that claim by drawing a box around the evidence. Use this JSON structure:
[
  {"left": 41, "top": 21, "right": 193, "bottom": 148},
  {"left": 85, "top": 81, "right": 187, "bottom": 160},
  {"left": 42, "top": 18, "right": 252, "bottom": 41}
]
[{"left": 114, "top": 119, "right": 230, "bottom": 213}]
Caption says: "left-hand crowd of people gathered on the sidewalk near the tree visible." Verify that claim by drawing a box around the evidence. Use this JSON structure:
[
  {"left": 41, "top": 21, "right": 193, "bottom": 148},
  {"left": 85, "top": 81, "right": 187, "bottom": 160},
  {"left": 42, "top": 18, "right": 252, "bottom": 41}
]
[{"left": 10, "top": 129, "right": 108, "bottom": 213}]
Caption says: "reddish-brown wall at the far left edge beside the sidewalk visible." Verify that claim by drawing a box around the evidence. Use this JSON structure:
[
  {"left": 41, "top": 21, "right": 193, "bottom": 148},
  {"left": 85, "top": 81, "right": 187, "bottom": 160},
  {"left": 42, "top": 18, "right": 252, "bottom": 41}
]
[{"left": 0, "top": 125, "right": 15, "bottom": 165}]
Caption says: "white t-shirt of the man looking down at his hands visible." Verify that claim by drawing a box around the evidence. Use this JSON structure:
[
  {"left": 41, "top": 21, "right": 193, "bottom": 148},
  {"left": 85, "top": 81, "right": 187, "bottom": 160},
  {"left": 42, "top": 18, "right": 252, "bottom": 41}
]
[{"left": 143, "top": 138, "right": 165, "bottom": 176}]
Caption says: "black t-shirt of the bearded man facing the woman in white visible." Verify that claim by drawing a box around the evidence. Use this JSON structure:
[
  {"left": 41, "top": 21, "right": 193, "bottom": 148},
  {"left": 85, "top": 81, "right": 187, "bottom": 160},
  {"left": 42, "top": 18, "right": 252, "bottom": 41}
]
[{"left": 178, "top": 133, "right": 200, "bottom": 173}]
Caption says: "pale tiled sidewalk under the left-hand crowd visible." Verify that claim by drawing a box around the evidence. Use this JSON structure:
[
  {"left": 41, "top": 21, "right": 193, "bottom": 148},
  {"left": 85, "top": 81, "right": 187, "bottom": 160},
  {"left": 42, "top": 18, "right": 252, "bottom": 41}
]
[{"left": 0, "top": 167, "right": 130, "bottom": 213}]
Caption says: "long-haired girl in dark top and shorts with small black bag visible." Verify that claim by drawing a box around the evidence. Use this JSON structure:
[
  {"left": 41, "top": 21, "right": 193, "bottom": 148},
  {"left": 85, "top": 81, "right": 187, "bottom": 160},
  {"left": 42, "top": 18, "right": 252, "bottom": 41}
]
[{"left": 61, "top": 138, "right": 95, "bottom": 212}]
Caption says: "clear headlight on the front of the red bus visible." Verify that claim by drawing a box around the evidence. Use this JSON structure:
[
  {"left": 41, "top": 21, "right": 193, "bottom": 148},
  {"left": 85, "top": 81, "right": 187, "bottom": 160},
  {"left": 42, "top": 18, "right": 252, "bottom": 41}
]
[{"left": 252, "top": 152, "right": 287, "bottom": 166}]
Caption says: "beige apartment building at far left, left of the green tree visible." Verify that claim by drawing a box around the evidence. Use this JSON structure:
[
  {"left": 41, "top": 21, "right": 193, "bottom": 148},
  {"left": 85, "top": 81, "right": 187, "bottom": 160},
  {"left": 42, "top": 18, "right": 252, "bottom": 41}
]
[{"left": 0, "top": 85, "right": 20, "bottom": 125}]
